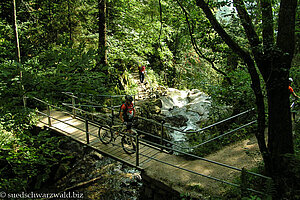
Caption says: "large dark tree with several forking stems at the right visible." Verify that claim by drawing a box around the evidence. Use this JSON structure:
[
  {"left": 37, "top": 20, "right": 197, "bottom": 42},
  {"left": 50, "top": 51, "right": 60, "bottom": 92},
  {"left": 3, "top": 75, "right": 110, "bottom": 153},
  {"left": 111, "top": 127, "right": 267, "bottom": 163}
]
[{"left": 196, "top": 0, "right": 297, "bottom": 195}]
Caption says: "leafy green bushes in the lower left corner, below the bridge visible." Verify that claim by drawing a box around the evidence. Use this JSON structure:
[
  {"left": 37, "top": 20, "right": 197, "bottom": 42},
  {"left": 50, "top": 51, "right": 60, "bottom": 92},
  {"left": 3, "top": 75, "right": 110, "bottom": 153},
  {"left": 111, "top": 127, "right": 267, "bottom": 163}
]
[{"left": 0, "top": 110, "right": 69, "bottom": 192}]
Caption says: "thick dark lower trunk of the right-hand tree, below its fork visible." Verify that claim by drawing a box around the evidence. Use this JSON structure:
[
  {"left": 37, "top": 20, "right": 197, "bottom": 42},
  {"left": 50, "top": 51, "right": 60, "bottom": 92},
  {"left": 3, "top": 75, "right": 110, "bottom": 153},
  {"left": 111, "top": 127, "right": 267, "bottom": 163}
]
[{"left": 266, "top": 64, "right": 294, "bottom": 199}]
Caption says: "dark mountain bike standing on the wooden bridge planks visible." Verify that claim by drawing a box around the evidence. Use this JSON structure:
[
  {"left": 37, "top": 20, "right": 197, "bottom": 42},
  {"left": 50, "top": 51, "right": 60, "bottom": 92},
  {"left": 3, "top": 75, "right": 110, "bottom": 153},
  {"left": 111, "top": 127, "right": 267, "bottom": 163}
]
[{"left": 98, "top": 123, "right": 137, "bottom": 154}]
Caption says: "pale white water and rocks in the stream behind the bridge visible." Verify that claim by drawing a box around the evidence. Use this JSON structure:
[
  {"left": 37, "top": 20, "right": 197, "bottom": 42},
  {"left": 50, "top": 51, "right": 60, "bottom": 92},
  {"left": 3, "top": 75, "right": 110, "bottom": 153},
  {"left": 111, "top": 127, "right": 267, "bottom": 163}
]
[{"left": 161, "top": 88, "right": 211, "bottom": 142}]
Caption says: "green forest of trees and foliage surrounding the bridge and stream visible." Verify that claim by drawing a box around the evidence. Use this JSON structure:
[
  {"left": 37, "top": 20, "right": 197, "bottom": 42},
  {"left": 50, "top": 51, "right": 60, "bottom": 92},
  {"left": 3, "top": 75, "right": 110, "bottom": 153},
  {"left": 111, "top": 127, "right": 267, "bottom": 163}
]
[{"left": 0, "top": 0, "right": 300, "bottom": 199}]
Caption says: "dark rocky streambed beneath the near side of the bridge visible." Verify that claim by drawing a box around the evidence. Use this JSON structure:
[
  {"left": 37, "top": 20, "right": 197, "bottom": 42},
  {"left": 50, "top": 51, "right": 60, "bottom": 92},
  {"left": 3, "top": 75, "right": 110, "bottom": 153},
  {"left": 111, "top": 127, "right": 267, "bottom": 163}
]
[{"left": 39, "top": 138, "right": 142, "bottom": 200}]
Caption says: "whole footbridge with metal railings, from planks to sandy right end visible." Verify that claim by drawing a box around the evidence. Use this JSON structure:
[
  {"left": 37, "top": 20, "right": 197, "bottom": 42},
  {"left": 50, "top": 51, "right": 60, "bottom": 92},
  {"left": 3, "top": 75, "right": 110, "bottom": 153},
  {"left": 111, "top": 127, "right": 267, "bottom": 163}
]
[{"left": 27, "top": 92, "right": 271, "bottom": 197}]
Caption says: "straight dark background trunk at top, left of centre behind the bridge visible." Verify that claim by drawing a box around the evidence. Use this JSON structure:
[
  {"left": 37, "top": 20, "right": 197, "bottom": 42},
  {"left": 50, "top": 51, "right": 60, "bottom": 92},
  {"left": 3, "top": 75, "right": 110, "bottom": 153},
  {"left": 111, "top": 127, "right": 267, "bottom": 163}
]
[{"left": 98, "top": 0, "right": 107, "bottom": 67}]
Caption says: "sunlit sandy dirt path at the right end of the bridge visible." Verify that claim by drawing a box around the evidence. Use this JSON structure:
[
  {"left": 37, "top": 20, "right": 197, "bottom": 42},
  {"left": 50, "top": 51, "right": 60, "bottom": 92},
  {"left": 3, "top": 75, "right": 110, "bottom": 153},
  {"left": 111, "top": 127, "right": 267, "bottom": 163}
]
[{"left": 145, "top": 137, "right": 262, "bottom": 197}]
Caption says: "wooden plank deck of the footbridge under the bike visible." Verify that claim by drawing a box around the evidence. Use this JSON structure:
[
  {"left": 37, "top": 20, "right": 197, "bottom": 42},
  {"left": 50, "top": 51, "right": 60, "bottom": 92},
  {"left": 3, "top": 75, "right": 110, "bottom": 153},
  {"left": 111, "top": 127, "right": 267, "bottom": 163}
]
[{"left": 37, "top": 110, "right": 161, "bottom": 169}]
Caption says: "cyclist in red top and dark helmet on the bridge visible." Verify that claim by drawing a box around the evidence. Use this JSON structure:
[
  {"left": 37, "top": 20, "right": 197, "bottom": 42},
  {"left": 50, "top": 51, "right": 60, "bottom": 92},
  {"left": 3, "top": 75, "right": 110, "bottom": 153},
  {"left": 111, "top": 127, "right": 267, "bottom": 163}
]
[{"left": 120, "top": 95, "right": 135, "bottom": 133}]
